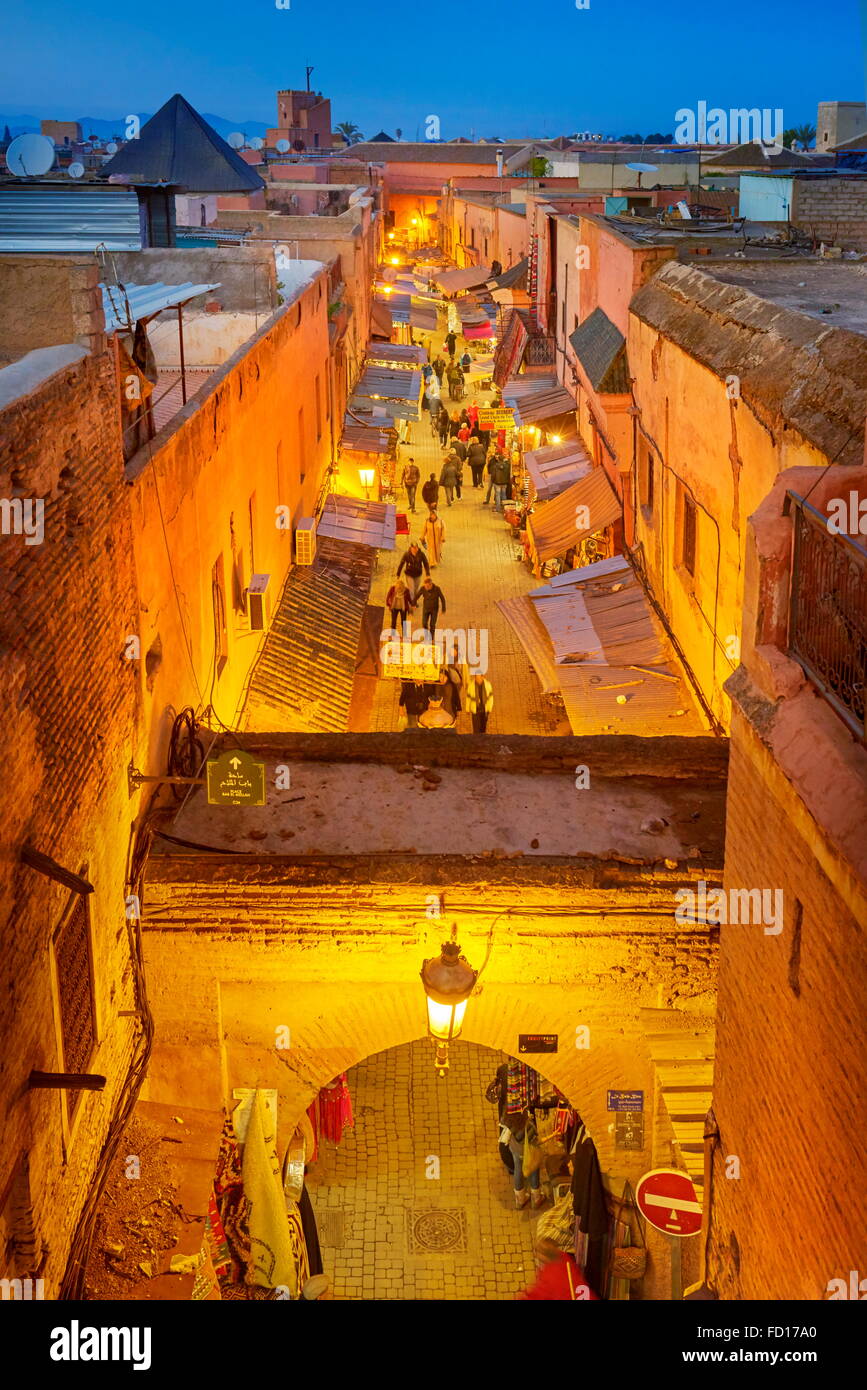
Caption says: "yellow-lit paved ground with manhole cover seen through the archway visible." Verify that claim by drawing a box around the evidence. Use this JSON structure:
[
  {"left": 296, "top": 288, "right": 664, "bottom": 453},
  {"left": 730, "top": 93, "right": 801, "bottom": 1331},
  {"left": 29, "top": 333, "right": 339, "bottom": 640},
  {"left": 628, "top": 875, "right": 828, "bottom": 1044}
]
[{"left": 307, "top": 1038, "right": 550, "bottom": 1301}]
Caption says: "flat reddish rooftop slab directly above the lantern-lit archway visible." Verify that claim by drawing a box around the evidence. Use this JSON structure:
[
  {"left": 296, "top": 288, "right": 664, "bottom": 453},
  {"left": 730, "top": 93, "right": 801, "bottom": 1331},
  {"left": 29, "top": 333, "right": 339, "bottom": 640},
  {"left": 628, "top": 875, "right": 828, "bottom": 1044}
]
[{"left": 161, "top": 734, "right": 725, "bottom": 869}]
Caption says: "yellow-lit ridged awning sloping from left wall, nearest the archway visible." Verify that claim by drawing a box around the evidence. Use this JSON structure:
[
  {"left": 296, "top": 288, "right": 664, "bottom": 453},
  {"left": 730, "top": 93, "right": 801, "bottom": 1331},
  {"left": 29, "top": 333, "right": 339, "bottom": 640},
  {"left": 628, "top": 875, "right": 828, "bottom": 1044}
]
[{"left": 245, "top": 537, "right": 377, "bottom": 734}]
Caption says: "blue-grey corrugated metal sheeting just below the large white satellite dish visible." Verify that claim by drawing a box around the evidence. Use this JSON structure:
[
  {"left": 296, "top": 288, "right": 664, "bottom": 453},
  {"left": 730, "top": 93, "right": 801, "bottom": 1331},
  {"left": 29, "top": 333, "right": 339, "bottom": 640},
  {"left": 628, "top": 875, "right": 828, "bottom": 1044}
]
[{"left": 0, "top": 182, "right": 142, "bottom": 252}]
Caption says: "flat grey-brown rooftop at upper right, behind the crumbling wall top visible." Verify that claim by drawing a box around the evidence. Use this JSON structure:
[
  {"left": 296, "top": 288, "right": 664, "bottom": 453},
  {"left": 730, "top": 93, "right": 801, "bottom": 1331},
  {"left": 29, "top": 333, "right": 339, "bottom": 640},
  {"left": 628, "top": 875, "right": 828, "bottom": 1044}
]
[{"left": 711, "top": 259, "right": 867, "bottom": 336}]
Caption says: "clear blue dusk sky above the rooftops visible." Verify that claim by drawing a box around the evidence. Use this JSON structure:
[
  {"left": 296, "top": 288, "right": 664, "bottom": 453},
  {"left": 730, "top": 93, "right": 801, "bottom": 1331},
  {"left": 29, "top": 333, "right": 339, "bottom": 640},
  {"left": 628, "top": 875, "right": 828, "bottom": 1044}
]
[{"left": 0, "top": 0, "right": 867, "bottom": 139}]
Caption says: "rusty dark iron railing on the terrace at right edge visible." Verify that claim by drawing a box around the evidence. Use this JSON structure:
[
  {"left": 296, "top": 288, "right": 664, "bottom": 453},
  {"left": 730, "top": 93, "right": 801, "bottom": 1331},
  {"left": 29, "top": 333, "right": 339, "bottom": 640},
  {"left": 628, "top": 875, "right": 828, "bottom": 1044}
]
[{"left": 788, "top": 492, "right": 867, "bottom": 742}]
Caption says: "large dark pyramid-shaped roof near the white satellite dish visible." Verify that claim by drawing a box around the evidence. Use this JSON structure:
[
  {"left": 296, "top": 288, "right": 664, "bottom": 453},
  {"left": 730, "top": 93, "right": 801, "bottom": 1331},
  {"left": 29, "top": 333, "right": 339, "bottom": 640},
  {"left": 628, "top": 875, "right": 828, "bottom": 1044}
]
[{"left": 101, "top": 92, "right": 265, "bottom": 193}]
